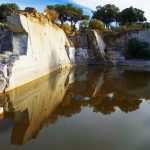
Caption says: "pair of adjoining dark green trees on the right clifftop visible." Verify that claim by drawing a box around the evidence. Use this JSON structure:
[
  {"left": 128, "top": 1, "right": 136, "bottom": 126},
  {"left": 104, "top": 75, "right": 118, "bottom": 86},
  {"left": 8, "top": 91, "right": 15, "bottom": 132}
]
[{"left": 92, "top": 4, "right": 147, "bottom": 28}]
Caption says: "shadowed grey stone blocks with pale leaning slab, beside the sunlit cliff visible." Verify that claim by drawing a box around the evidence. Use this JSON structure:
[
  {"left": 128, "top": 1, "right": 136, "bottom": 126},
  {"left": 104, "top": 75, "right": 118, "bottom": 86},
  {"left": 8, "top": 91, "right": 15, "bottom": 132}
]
[{"left": 70, "top": 30, "right": 106, "bottom": 65}]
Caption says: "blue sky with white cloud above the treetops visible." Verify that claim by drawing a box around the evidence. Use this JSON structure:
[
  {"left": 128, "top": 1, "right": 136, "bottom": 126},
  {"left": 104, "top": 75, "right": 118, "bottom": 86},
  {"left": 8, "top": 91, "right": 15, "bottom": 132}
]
[{"left": 0, "top": 0, "right": 150, "bottom": 21}]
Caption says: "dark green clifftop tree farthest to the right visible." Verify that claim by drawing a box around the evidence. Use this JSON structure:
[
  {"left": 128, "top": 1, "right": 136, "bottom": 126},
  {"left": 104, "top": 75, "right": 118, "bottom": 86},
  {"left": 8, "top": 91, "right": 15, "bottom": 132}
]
[{"left": 119, "top": 7, "right": 147, "bottom": 25}]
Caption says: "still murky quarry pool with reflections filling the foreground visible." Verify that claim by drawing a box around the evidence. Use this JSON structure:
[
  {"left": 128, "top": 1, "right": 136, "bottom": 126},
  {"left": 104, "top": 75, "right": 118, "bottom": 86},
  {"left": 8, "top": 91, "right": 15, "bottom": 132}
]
[{"left": 0, "top": 66, "right": 150, "bottom": 150}]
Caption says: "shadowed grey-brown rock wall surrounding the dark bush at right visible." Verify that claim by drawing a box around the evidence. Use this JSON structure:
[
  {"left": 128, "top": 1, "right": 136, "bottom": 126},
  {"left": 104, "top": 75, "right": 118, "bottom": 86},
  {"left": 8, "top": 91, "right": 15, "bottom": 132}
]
[{"left": 104, "top": 29, "right": 150, "bottom": 64}]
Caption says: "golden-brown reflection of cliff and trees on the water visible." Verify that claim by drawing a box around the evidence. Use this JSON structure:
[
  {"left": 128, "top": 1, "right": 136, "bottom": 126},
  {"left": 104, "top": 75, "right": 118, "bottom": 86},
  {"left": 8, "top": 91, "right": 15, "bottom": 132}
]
[{"left": 1, "top": 67, "right": 150, "bottom": 145}]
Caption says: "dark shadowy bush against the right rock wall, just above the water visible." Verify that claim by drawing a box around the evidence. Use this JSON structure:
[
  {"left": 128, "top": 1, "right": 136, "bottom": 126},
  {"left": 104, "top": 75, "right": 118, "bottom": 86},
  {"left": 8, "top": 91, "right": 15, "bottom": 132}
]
[{"left": 128, "top": 38, "right": 150, "bottom": 60}]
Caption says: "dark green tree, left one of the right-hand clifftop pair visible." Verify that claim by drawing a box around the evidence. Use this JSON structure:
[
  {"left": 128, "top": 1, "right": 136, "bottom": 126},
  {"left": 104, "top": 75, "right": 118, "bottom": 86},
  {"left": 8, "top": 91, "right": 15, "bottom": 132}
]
[{"left": 92, "top": 4, "right": 120, "bottom": 28}]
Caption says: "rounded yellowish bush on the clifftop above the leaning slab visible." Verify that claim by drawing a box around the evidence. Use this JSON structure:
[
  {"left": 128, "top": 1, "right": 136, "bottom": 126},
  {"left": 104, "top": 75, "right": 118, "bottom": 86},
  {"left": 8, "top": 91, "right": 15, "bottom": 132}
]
[{"left": 89, "top": 19, "right": 105, "bottom": 30}]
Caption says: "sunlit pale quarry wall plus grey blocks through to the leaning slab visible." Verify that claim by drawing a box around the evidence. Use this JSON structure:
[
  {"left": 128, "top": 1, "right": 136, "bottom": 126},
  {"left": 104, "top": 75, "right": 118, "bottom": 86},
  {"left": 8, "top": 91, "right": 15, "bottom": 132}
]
[{"left": 0, "top": 11, "right": 106, "bottom": 93}]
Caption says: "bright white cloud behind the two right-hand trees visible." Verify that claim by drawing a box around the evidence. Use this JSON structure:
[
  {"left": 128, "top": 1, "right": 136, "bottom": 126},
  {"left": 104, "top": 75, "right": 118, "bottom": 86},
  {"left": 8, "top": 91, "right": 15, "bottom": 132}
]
[{"left": 71, "top": 0, "right": 150, "bottom": 21}]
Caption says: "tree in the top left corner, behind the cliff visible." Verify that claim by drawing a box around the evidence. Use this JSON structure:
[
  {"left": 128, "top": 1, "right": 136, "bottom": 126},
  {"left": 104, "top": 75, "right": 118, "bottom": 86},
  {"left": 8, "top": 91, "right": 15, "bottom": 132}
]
[{"left": 0, "top": 3, "right": 19, "bottom": 22}]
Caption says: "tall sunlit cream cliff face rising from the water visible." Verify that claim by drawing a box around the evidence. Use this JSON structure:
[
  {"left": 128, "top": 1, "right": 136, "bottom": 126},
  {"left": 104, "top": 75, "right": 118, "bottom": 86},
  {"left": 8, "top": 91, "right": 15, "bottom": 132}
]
[{"left": 5, "top": 15, "right": 74, "bottom": 91}]
